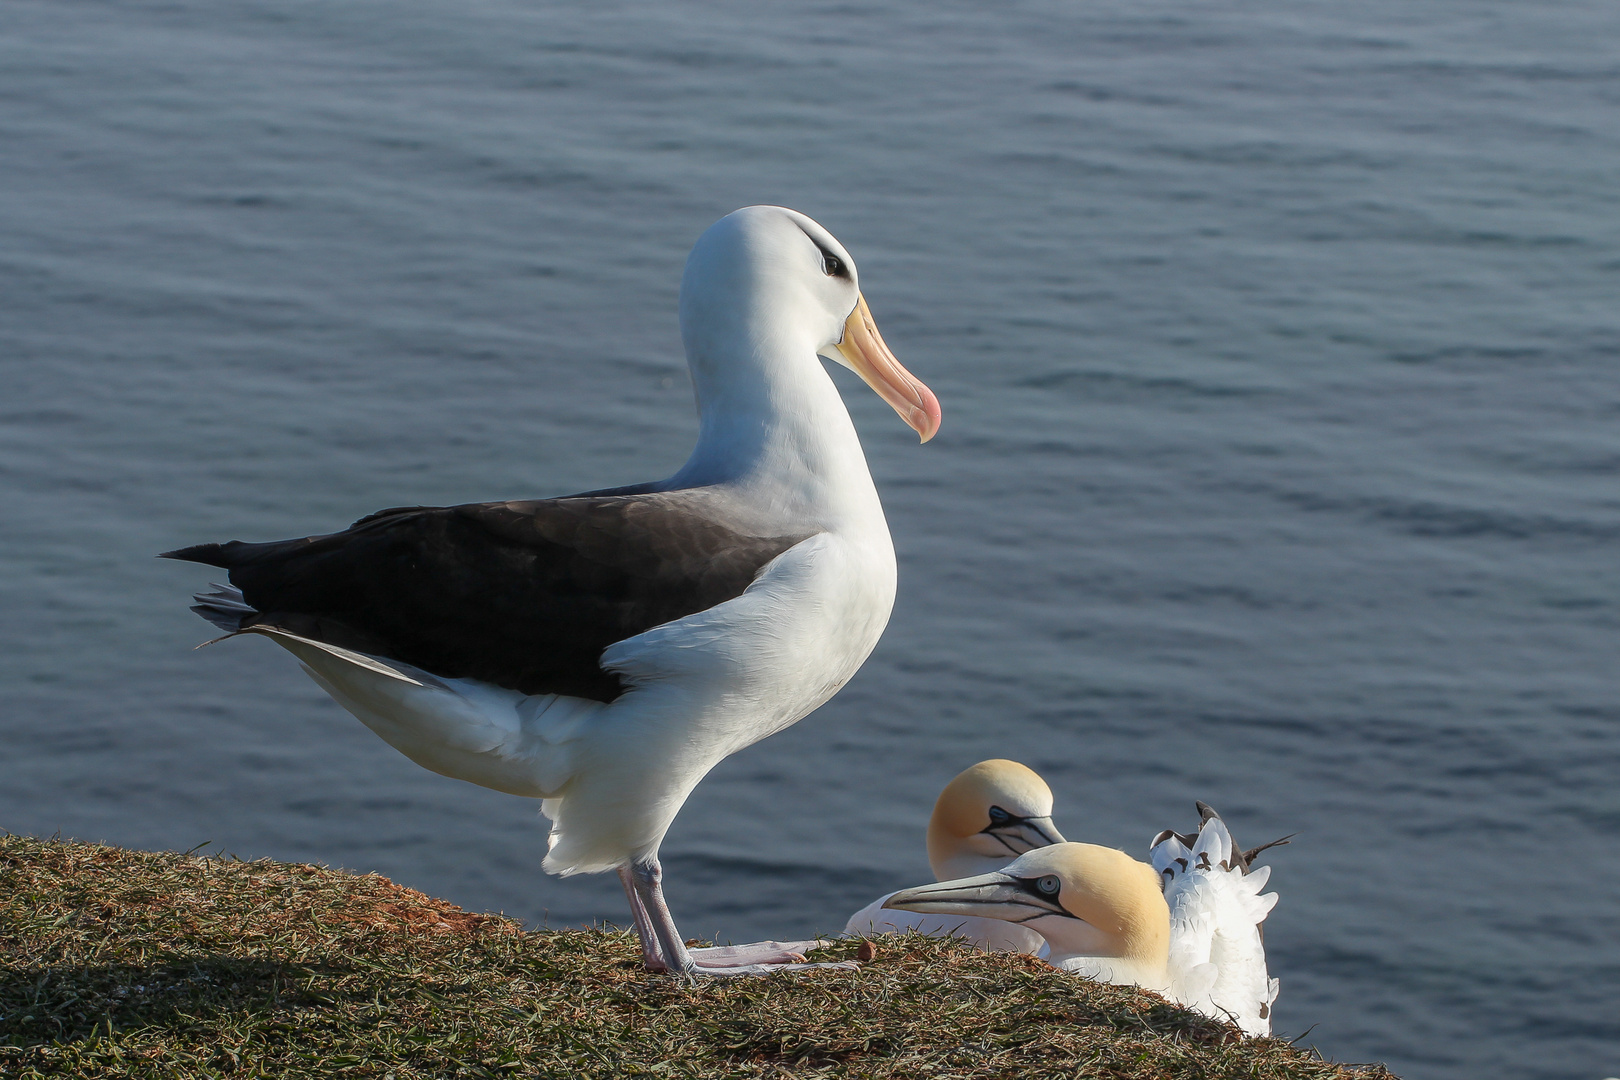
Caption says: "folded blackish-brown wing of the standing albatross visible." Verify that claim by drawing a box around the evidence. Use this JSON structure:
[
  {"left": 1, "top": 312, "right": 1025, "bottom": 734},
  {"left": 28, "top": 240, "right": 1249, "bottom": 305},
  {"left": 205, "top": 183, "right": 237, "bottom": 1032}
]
[{"left": 167, "top": 492, "right": 810, "bottom": 701}]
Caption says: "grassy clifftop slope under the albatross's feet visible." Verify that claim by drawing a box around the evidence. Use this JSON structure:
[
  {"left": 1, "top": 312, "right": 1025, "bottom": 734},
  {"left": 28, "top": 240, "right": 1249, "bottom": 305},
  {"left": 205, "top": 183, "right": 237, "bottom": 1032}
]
[{"left": 0, "top": 837, "right": 1390, "bottom": 1080}]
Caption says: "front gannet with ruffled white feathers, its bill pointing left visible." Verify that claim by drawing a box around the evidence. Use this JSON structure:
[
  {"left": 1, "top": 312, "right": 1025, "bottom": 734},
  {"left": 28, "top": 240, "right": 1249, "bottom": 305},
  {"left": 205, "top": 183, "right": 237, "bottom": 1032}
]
[{"left": 888, "top": 816, "right": 1278, "bottom": 1035}]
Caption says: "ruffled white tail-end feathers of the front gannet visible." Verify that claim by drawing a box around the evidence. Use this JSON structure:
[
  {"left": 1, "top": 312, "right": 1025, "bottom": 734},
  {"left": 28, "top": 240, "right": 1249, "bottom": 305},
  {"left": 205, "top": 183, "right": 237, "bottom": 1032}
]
[{"left": 1153, "top": 818, "right": 1277, "bottom": 1035}]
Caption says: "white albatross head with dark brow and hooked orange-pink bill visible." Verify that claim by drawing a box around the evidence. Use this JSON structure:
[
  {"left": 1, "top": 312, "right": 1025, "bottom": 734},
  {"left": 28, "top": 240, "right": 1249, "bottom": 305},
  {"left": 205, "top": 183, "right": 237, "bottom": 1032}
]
[{"left": 680, "top": 206, "right": 940, "bottom": 442}]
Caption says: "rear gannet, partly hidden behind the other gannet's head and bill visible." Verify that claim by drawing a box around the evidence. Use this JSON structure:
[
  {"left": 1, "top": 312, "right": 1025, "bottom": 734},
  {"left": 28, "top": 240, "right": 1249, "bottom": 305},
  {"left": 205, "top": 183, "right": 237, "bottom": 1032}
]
[{"left": 844, "top": 758, "right": 1063, "bottom": 955}]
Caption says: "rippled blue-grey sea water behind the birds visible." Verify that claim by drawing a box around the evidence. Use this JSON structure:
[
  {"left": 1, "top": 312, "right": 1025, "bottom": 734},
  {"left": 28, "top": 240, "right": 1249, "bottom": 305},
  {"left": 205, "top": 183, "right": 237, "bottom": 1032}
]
[{"left": 0, "top": 0, "right": 1620, "bottom": 1080}]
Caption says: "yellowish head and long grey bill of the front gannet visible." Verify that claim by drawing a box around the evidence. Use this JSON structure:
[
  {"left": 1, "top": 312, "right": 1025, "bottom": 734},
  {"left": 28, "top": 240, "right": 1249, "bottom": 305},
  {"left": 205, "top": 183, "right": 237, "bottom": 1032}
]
[{"left": 883, "top": 844, "right": 1170, "bottom": 965}]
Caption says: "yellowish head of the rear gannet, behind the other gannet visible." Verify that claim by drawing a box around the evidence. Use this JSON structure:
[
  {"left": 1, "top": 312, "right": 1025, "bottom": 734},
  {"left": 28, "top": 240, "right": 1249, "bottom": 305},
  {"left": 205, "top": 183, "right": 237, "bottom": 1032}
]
[{"left": 928, "top": 758, "right": 1063, "bottom": 881}]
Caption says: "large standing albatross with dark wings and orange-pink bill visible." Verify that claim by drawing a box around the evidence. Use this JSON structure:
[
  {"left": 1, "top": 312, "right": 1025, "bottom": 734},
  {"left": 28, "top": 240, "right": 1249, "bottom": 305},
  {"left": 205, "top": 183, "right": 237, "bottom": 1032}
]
[{"left": 157, "top": 206, "right": 940, "bottom": 976}]
